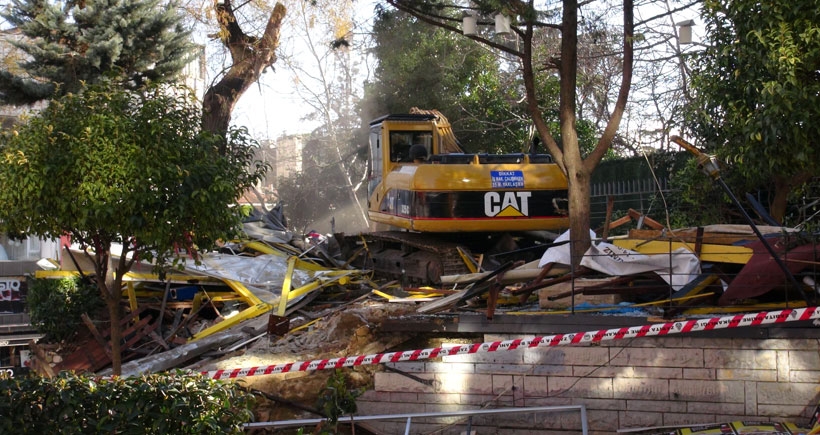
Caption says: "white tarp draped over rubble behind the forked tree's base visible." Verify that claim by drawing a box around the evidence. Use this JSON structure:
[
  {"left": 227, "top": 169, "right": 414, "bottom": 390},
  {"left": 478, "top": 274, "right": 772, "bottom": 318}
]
[{"left": 538, "top": 231, "right": 700, "bottom": 290}]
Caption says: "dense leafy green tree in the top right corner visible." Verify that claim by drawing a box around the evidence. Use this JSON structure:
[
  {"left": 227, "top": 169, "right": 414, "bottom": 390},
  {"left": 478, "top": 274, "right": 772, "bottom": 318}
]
[{"left": 688, "top": 0, "right": 820, "bottom": 220}]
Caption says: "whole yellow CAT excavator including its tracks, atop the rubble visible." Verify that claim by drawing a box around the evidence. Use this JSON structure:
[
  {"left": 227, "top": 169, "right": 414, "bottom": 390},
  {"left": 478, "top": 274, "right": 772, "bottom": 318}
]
[{"left": 352, "top": 108, "right": 569, "bottom": 283}]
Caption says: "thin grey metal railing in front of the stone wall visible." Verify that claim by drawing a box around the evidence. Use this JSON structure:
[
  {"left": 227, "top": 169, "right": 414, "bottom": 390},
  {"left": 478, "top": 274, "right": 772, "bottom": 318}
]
[{"left": 244, "top": 405, "right": 589, "bottom": 435}]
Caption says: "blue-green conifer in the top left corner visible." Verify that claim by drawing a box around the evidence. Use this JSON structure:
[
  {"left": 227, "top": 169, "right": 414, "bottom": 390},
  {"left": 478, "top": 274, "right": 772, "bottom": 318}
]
[{"left": 0, "top": 0, "right": 196, "bottom": 105}]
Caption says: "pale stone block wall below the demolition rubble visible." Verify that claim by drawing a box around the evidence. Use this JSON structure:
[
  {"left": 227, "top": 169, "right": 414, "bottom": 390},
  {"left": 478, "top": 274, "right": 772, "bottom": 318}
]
[{"left": 358, "top": 335, "right": 820, "bottom": 434}]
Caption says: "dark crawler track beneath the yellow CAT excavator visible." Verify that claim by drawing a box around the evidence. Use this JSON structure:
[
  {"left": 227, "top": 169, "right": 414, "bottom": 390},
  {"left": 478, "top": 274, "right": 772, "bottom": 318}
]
[{"left": 345, "top": 231, "right": 471, "bottom": 284}]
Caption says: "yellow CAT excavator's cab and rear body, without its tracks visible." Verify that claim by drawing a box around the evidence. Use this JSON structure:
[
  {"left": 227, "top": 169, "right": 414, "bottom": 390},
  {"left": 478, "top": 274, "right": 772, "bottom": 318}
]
[{"left": 368, "top": 112, "right": 569, "bottom": 233}]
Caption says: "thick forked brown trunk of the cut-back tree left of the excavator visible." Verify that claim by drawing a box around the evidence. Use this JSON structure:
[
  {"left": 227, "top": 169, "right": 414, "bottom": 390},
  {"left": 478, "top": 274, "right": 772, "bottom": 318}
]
[{"left": 202, "top": 0, "right": 286, "bottom": 148}]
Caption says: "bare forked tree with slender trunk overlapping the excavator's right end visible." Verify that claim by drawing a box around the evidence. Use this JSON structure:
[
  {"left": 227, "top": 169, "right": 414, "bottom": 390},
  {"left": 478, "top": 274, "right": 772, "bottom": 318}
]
[{"left": 386, "top": 0, "right": 635, "bottom": 264}]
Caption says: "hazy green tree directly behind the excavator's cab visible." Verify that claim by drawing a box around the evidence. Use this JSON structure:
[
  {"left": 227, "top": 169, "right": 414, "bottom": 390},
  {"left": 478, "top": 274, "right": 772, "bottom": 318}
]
[{"left": 361, "top": 8, "right": 528, "bottom": 152}]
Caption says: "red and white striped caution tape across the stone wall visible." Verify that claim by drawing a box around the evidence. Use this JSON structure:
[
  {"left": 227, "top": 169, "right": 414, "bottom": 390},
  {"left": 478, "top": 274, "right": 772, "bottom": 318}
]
[{"left": 201, "top": 307, "right": 820, "bottom": 379}]
